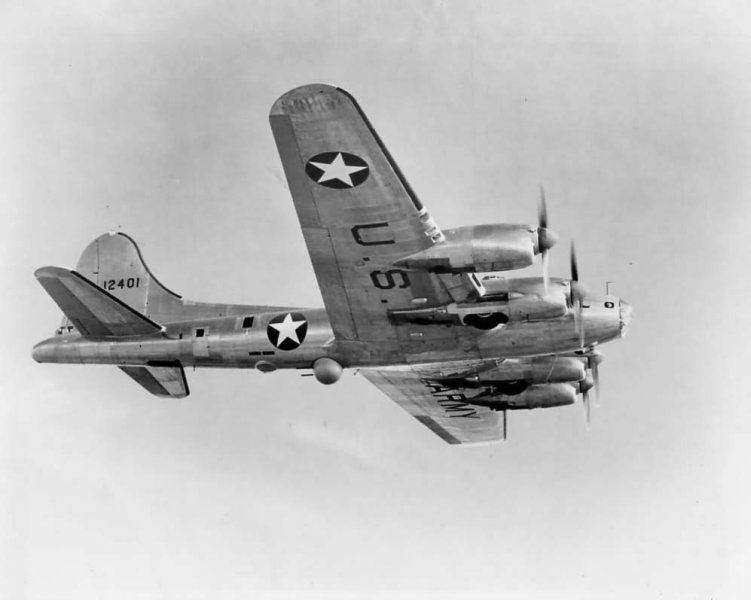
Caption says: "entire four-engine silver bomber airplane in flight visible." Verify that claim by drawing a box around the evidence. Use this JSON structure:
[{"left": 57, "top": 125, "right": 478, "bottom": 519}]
[{"left": 32, "top": 84, "right": 631, "bottom": 444}]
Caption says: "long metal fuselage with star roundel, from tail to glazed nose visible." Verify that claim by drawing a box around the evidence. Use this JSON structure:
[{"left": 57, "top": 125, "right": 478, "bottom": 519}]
[{"left": 33, "top": 297, "right": 630, "bottom": 372}]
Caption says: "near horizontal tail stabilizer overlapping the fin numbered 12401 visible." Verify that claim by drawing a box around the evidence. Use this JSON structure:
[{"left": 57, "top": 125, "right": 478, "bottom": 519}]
[{"left": 34, "top": 267, "right": 163, "bottom": 340}]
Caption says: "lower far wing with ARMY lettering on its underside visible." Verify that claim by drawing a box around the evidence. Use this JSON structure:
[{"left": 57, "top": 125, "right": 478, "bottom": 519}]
[{"left": 360, "top": 369, "right": 506, "bottom": 444}]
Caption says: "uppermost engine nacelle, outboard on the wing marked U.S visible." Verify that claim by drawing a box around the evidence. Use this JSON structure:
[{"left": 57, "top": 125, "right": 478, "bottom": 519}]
[{"left": 394, "top": 225, "right": 555, "bottom": 273}]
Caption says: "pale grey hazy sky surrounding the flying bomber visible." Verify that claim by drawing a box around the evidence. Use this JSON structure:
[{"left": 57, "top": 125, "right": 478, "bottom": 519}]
[{"left": 0, "top": 0, "right": 751, "bottom": 600}]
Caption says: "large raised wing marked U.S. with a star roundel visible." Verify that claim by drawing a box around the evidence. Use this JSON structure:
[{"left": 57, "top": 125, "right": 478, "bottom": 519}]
[{"left": 269, "top": 84, "right": 466, "bottom": 342}]
